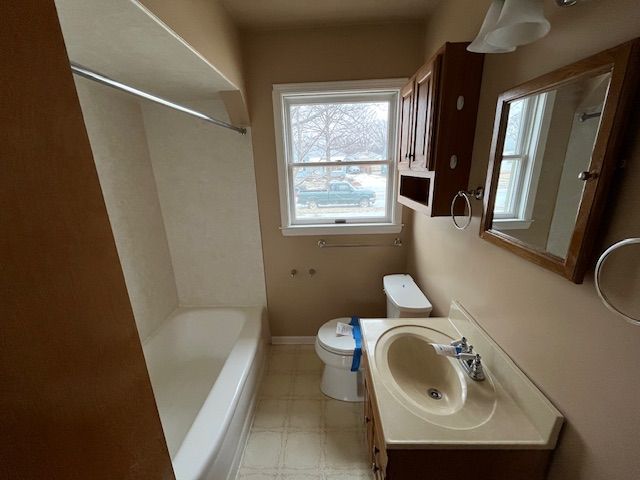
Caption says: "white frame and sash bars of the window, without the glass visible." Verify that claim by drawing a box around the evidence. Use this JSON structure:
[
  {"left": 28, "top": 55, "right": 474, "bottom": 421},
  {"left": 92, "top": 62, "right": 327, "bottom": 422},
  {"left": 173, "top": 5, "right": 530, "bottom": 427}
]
[{"left": 273, "top": 79, "right": 407, "bottom": 236}]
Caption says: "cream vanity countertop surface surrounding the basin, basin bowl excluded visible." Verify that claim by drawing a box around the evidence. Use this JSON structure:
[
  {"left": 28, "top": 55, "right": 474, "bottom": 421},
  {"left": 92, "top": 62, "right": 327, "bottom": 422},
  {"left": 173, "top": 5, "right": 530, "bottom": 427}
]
[{"left": 361, "top": 302, "right": 564, "bottom": 449}]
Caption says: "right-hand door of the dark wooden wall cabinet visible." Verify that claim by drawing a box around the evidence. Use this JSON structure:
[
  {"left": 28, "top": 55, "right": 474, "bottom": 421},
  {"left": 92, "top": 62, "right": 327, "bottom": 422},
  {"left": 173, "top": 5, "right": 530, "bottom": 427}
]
[{"left": 410, "top": 55, "right": 441, "bottom": 170}]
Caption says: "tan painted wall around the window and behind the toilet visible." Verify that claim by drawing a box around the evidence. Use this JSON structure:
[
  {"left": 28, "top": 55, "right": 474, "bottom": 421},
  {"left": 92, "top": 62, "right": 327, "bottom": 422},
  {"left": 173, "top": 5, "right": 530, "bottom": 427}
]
[{"left": 243, "top": 24, "right": 423, "bottom": 336}]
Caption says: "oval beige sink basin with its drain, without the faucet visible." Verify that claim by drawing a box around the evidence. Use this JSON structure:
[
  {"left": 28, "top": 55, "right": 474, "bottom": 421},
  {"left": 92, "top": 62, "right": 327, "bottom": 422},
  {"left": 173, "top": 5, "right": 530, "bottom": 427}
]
[{"left": 375, "top": 325, "right": 497, "bottom": 430}]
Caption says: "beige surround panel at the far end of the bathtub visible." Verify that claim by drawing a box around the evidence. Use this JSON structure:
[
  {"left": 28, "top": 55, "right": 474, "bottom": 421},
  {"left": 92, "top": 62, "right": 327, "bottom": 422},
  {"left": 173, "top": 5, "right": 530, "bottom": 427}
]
[{"left": 142, "top": 99, "right": 266, "bottom": 306}]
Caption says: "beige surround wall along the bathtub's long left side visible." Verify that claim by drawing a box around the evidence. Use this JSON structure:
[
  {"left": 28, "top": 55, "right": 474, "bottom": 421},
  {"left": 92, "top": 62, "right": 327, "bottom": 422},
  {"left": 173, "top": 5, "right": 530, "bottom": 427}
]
[{"left": 76, "top": 77, "right": 178, "bottom": 340}]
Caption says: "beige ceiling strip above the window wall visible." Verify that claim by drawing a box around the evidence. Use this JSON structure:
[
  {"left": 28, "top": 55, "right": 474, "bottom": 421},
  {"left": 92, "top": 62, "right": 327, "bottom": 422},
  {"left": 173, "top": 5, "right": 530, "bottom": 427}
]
[{"left": 218, "top": 0, "right": 439, "bottom": 28}]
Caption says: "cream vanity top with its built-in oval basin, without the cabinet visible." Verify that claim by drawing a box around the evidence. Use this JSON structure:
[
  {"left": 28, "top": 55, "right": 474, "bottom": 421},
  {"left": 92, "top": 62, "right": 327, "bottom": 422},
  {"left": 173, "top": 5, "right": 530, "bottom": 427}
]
[{"left": 360, "top": 302, "right": 563, "bottom": 450}]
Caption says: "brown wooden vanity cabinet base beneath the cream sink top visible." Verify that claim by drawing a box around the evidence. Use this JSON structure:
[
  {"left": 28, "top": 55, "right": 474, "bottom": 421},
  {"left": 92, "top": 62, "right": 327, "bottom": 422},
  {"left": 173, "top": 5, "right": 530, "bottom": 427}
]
[{"left": 362, "top": 351, "right": 551, "bottom": 480}]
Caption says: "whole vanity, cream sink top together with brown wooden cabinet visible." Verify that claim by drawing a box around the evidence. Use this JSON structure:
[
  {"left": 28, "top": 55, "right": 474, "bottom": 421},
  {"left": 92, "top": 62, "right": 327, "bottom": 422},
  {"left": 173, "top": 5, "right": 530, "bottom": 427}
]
[{"left": 361, "top": 302, "right": 564, "bottom": 480}]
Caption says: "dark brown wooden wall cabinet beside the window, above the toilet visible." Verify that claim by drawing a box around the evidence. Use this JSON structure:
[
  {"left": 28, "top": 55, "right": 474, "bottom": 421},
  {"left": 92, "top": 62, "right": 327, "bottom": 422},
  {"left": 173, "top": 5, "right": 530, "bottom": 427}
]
[{"left": 397, "top": 43, "right": 484, "bottom": 216}]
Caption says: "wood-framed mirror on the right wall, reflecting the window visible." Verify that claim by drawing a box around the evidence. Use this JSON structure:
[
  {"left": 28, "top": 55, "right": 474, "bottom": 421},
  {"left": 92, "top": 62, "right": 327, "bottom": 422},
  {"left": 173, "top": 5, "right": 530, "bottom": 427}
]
[{"left": 481, "top": 42, "right": 637, "bottom": 283}]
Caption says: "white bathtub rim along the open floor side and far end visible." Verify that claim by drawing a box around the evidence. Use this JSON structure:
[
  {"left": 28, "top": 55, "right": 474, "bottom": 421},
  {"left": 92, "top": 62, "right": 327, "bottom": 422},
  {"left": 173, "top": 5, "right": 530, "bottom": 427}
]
[{"left": 172, "top": 306, "right": 262, "bottom": 480}]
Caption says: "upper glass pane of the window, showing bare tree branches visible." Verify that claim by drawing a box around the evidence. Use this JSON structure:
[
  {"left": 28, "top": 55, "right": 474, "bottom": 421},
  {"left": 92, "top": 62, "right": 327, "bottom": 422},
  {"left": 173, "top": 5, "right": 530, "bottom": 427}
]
[{"left": 289, "top": 101, "right": 389, "bottom": 163}]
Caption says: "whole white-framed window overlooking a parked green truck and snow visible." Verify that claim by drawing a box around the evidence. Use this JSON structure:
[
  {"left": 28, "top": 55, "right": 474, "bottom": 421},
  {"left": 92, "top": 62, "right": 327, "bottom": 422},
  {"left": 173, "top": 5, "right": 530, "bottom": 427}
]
[{"left": 273, "top": 80, "right": 405, "bottom": 235}]
